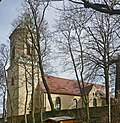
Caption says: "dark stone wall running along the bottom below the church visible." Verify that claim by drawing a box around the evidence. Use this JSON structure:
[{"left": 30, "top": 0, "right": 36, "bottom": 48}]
[{"left": 8, "top": 104, "right": 120, "bottom": 123}]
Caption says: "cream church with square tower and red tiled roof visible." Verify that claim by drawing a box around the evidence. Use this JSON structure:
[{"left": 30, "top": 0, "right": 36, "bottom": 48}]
[{"left": 7, "top": 28, "right": 105, "bottom": 123}]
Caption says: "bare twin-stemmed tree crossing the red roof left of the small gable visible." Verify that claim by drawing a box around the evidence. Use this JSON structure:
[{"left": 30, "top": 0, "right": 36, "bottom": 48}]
[{"left": 57, "top": 6, "right": 90, "bottom": 123}]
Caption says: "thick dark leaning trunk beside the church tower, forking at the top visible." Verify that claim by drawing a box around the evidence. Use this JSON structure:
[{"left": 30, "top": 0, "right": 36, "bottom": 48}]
[{"left": 22, "top": 1, "right": 54, "bottom": 115}]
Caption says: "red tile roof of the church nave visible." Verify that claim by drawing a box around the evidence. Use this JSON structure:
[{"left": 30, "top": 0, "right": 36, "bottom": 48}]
[{"left": 40, "top": 76, "right": 105, "bottom": 95}]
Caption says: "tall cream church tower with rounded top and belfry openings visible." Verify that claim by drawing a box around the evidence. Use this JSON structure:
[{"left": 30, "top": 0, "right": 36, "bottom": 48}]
[{"left": 7, "top": 28, "right": 40, "bottom": 119}]
